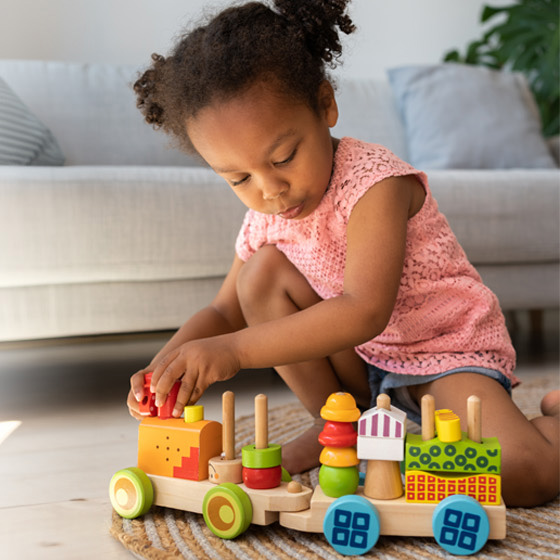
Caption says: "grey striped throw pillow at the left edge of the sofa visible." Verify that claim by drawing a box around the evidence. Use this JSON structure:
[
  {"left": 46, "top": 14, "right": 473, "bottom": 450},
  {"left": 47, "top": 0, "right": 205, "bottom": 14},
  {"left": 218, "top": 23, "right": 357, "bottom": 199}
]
[{"left": 0, "top": 78, "right": 64, "bottom": 165}]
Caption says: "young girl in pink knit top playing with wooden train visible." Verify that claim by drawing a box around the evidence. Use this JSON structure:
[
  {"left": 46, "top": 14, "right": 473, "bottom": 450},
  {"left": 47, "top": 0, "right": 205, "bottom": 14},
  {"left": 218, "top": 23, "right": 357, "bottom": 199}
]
[{"left": 128, "top": 0, "right": 559, "bottom": 505}]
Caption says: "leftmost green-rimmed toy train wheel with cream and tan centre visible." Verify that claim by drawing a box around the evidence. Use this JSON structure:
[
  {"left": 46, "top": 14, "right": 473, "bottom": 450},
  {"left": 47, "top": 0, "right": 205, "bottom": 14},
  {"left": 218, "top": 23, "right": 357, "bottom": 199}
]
[{"left": 109, "top": 467, "right": 154, "bottom": 519}]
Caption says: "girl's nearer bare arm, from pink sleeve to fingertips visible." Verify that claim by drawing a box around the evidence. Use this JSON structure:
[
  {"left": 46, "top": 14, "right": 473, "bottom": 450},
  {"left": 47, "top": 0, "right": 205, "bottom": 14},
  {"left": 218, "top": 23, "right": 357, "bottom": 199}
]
[{"left": 152, "top": 176, "right": 424, "bottom": 415}]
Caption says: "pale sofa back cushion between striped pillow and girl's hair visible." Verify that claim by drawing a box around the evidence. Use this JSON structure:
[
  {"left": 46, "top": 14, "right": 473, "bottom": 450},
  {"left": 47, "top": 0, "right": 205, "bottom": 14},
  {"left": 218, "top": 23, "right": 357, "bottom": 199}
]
[{"left": 0, "top": 60, "right": 201, "bottom": 166}]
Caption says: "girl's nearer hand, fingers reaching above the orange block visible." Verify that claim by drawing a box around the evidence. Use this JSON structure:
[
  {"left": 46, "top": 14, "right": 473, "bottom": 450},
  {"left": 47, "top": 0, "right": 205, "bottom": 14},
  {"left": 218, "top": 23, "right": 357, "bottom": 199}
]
[{"left": 149, "top": 335, "right": 240, "bottom": 418}]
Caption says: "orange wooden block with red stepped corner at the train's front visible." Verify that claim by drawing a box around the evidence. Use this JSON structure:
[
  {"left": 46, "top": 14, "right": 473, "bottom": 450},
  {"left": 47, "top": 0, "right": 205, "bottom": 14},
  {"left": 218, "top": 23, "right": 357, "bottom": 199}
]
[{"left": 138, "top": 417, "right": 222, "bottom": 480}]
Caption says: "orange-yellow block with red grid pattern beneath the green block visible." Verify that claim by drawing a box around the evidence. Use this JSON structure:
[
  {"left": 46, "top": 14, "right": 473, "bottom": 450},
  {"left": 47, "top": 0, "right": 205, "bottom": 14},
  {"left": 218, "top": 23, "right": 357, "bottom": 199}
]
[{"left": 405, "top": 471, "right": 502, "bottom": 506}]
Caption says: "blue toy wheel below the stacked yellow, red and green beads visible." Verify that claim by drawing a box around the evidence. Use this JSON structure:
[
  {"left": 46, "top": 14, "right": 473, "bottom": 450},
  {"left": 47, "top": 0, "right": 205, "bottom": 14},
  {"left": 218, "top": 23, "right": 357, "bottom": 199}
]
[{"left": 323, "top": 495, "right": 380, "bottom": 556}]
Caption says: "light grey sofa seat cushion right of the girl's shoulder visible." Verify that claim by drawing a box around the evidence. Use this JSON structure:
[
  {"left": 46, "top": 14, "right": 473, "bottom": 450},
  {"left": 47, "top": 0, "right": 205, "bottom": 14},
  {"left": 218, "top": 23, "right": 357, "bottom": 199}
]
[{"left": 428, "top": 169, "right": 560, "bottom": 264}]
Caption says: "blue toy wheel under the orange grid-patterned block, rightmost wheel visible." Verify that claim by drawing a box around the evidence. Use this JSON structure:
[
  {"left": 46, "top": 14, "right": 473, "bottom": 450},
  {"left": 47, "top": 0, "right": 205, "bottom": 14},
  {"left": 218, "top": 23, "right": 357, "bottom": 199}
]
[{"left": 432, "top": 495, "right": 490, "bottom": 555}]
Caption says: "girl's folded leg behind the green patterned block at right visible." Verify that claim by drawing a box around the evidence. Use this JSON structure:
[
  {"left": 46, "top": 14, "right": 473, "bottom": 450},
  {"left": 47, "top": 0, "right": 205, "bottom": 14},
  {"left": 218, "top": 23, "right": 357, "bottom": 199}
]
[{"left": 409, "top": 373, "right": 560, "bottom": 506}]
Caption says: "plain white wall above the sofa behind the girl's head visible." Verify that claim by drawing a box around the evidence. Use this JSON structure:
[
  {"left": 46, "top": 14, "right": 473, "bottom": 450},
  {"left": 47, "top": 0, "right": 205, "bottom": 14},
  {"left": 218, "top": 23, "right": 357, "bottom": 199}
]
[{"left": 0, "top": 0, "right": 508, "bottom": 77}]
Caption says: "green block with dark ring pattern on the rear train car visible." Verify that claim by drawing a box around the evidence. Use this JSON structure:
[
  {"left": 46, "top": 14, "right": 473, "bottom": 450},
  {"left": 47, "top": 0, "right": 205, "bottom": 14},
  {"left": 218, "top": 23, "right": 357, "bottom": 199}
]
[{"left": 405, "top": 432, "right": 502, "bottom": 474}]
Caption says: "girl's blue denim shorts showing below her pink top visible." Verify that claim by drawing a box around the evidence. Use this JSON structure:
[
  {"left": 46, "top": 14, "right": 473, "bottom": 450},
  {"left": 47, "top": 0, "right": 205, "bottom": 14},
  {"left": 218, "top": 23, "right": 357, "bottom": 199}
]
[{"left": 366, "top": 364, "right": 511, "bottom": 424}]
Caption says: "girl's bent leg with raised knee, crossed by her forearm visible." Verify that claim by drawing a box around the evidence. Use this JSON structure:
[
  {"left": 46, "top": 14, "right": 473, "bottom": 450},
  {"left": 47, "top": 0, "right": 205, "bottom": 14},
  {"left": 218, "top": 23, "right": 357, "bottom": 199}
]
[{"left": 237, "top": 245, "right": 370, "bottom": 474}]
